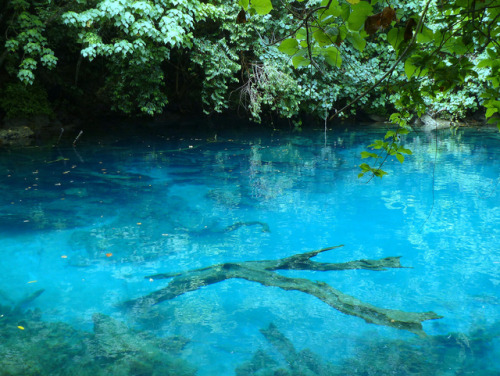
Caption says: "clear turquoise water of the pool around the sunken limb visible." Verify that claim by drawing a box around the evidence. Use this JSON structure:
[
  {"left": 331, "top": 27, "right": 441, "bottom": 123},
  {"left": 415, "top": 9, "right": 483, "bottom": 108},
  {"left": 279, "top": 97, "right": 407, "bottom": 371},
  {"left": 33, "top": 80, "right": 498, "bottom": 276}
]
[{"left": 0, "top": 122, "right": 500, "bottom": 376}]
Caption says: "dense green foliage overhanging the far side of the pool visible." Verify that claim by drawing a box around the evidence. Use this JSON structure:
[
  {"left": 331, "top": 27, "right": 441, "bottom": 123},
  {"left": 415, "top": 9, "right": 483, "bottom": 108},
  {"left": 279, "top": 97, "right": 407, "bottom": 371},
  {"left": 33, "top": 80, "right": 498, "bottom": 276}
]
[{"left": 0, "top": 0, "right": 500, "bottom": 128}]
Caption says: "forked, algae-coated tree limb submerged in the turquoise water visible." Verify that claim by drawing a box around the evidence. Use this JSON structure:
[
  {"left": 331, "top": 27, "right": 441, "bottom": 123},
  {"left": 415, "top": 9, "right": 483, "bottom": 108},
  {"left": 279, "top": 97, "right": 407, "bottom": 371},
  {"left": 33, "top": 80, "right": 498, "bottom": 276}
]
[{"left": 124, "top": 246, "right": 441, "bottom": 335}]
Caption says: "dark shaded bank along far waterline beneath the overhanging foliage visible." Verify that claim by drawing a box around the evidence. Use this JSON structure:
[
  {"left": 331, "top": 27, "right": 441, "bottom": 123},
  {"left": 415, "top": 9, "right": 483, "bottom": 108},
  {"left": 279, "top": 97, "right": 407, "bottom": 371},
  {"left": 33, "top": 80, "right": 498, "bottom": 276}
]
[{"left": 0, "top": 108, "right": 496, "bottom": 147}]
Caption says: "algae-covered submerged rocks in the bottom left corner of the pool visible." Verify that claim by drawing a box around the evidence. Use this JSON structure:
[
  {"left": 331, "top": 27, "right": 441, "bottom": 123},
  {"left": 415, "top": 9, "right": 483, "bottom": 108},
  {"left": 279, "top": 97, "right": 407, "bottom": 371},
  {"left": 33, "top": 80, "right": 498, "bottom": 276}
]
[{"left": 0, "top": 307, "right": 196, "bottom": 376}]
